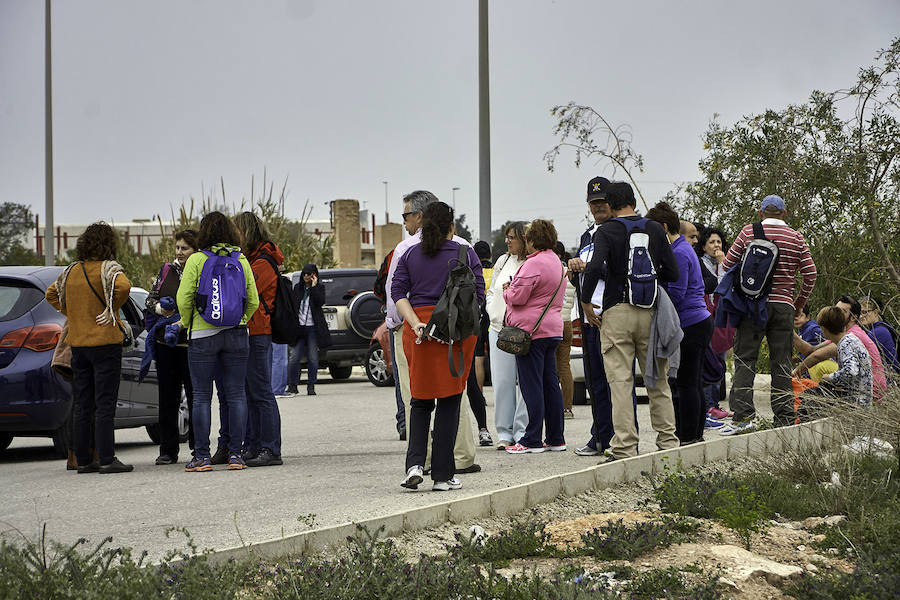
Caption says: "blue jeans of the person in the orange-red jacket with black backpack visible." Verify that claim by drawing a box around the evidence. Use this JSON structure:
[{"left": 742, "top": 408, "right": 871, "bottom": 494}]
[{"left": 244, "top": 334, "right": 281, "bottom": 454}]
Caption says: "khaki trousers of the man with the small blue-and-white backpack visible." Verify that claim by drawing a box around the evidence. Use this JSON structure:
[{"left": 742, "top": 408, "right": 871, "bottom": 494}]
[{"left": 600, "top": 303, "right": 678, "bottom": 458}]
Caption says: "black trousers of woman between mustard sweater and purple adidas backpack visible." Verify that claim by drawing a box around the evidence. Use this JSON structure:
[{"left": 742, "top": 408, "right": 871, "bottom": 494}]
[{"left": 156, "top": 343, "right": 194, "bottom": 458}]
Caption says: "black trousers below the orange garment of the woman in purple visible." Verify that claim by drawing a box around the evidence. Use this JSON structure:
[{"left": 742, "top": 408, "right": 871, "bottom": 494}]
[{"left": 406, "top": 394, "right": 462, "bottom": 481}]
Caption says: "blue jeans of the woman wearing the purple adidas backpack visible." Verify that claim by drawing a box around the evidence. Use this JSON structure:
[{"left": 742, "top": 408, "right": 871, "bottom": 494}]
[{"left": 188, "top": 327, "right": 250, "bottom": 458}]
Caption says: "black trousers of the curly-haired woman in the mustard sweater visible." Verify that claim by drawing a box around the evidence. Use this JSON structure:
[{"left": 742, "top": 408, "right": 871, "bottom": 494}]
[{"left": 72, "top": 344, "right": 122, "bottom": 466}]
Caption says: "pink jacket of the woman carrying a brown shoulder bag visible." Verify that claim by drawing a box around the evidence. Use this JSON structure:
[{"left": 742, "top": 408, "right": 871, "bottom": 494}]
[{"left": 503, "top": 250, "right": 566, "bottom": 339}]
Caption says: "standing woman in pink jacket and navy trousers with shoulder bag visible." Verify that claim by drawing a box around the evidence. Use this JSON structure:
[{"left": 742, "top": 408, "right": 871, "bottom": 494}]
[{"left": 503, "top": 219, "right": 566, "bottom": 454}]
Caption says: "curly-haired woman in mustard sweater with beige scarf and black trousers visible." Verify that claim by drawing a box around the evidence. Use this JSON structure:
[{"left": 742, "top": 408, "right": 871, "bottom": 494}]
[{"left": 46, "top": 222, "right": 134, "bottom": 473}]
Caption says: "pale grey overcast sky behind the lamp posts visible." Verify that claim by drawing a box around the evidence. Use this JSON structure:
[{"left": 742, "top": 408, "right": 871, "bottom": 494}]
[{"left": 0, "top": 0, "right": 900, "bottom": 244}]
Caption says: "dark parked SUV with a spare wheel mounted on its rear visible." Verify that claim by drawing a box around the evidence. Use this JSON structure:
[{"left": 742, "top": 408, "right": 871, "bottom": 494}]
[{"left": 291, "top": 269, "right": 384, "bottom": 379}]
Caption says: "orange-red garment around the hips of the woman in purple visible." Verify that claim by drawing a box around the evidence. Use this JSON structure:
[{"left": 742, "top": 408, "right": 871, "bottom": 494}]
[{"left": 403, "top": 306, "right": 477, "bottom": 399}]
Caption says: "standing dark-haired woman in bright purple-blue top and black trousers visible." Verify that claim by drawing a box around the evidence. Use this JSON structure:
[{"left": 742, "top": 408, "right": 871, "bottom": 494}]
[{"left": 647, "top": 202, "right": 713, "bottom": 446}]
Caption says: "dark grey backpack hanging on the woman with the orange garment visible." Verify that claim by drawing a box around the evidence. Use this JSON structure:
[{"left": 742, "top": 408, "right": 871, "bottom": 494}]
[{"left": 425, "top": 244, "right": 481, "bottom": 377}]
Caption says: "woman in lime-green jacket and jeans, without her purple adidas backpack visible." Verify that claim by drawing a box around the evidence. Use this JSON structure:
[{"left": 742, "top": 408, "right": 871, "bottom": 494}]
[{"left": 176, "top": 211, "right": 259, "bottom": 473}]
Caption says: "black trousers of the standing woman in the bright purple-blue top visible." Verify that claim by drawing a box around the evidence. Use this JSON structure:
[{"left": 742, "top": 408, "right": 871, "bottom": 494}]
[{"left": 672, "top": 317, "right": 713, "bottom": 442}]
